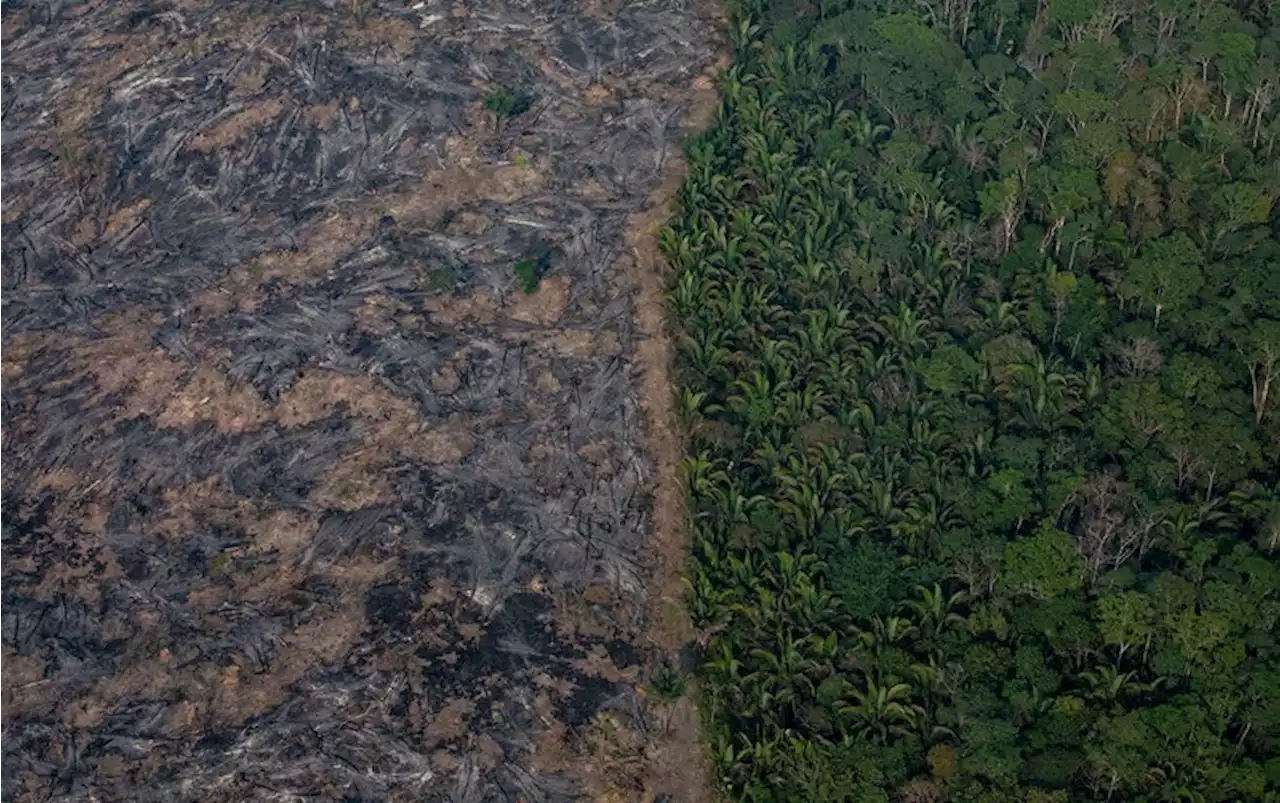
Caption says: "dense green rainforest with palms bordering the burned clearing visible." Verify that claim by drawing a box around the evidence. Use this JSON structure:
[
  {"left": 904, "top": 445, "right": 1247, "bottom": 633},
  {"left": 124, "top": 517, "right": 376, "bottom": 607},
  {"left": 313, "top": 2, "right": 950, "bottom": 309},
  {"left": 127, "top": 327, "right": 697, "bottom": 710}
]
[{"left": 660, "top": 0, "right": 1280, "bottom": 803}]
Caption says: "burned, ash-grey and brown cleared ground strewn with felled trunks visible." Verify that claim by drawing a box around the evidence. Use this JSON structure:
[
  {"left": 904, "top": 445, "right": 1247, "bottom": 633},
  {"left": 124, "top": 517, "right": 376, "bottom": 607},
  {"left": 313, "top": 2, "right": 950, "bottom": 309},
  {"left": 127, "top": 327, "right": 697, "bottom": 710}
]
[{"left": 0, "top": 0, "right": 719, "bottom": 803}]
